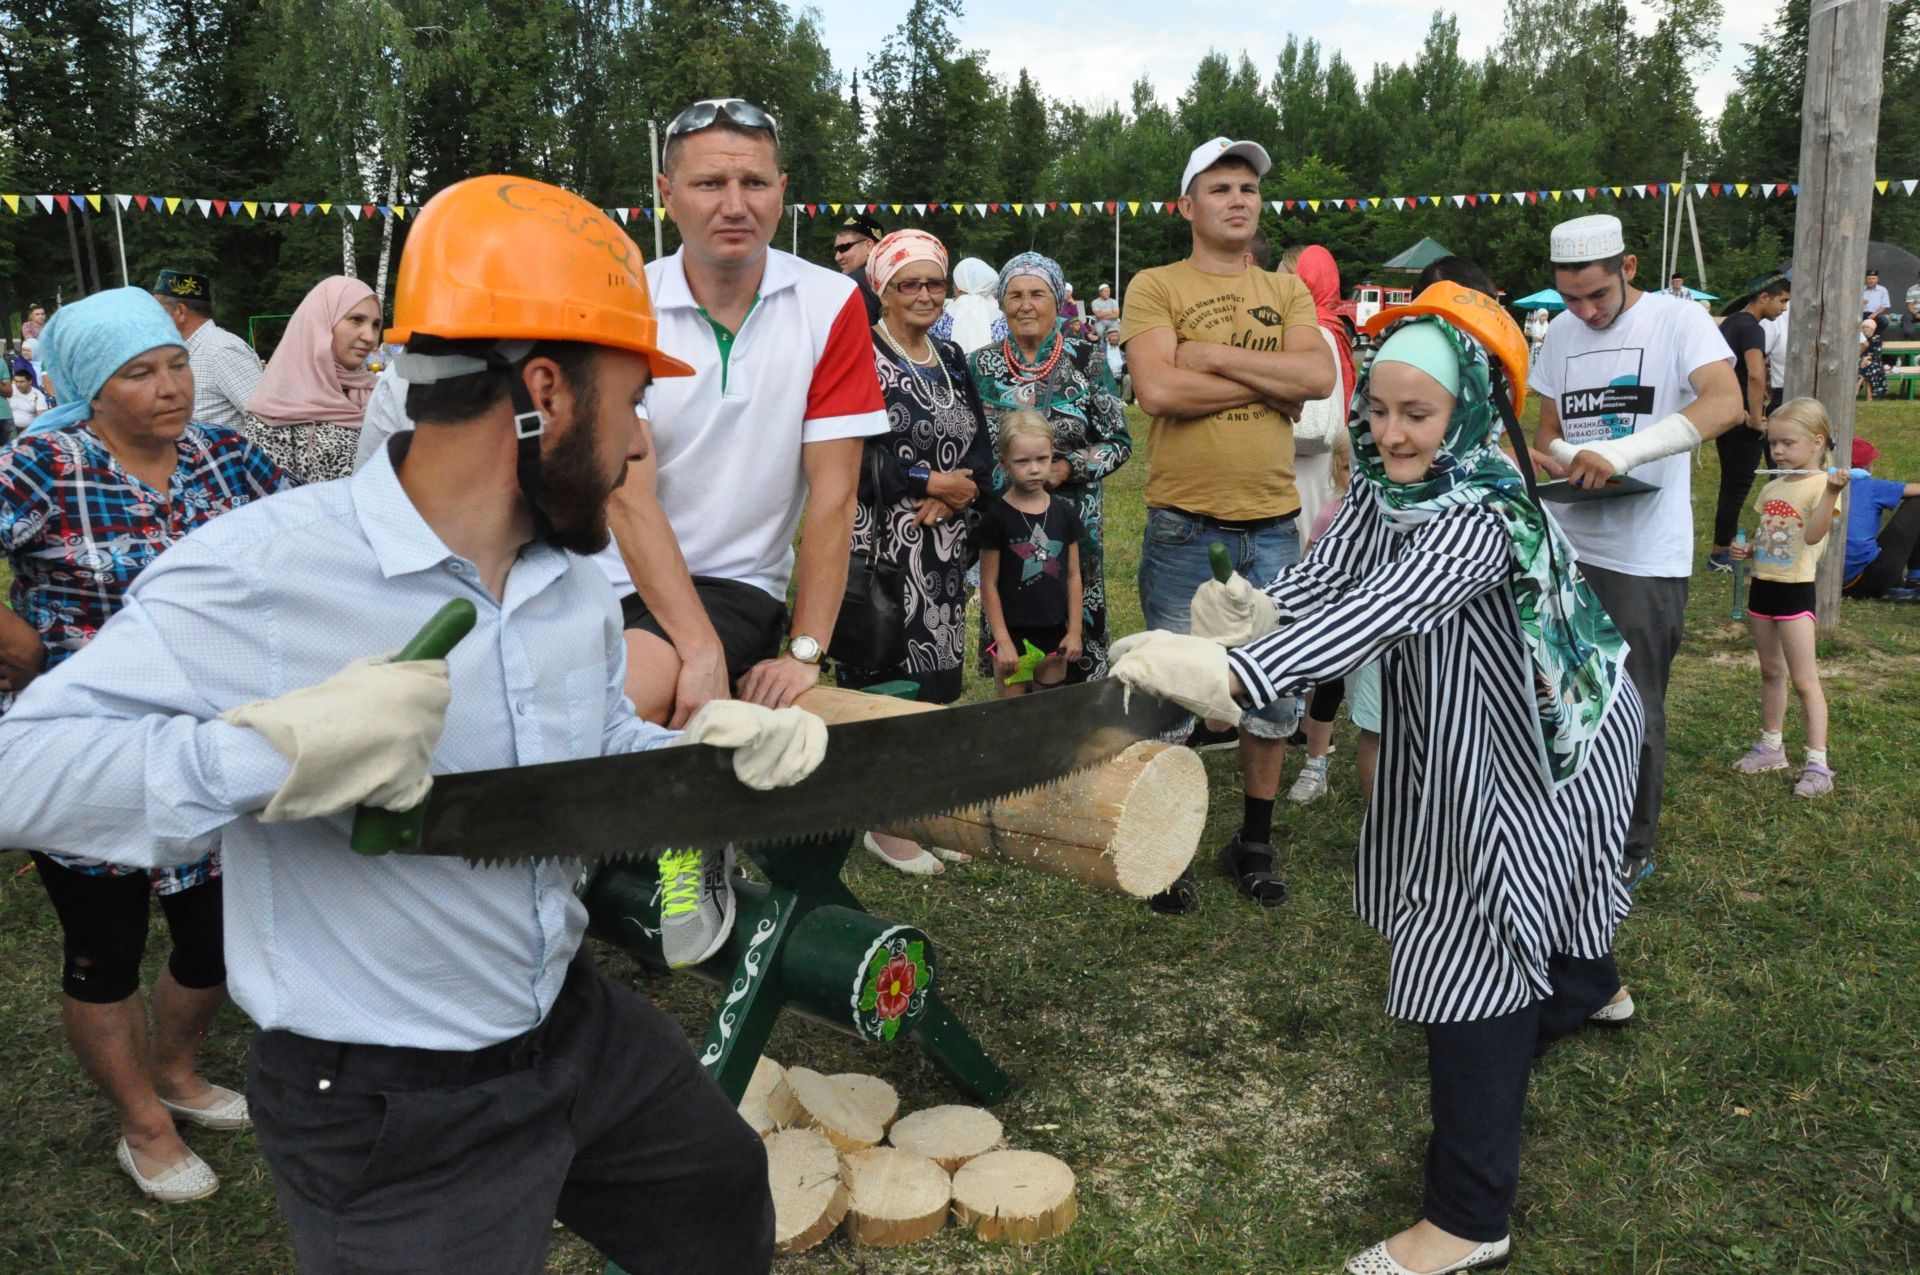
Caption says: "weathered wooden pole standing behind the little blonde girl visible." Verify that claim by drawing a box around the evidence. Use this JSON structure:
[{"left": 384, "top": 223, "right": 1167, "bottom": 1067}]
[{"left": 1788, "top": 0, "right": 1887, "bottom": 628}]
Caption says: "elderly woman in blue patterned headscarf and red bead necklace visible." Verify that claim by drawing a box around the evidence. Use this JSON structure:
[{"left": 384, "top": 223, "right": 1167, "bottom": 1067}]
[{"left": 970, "top": 252, "right": 1133, "bottom": 682}]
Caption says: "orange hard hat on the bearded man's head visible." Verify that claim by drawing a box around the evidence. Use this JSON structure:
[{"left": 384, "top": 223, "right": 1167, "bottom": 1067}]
[{"left": 386, "top": 177, "right": 693, "bottom": 376}]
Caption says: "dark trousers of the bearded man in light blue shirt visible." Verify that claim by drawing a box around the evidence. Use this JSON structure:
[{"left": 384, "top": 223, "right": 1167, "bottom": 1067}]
[{"left": 248, "top": 954, "right": 774, "bottom": 1275}]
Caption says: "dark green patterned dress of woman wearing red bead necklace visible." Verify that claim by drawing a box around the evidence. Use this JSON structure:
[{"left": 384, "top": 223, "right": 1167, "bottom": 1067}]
[{"left": 972, "top": 332, "right": 1133, "bottom": 682}]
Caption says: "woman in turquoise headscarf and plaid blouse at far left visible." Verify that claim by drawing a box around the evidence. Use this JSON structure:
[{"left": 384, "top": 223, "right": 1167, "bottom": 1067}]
[{"left": 0, "top": 288, "right": 284, "bottom": 1200}]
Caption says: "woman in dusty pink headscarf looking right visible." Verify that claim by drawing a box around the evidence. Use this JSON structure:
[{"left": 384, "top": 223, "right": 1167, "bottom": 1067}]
[{"left": 246, "top": 275, "right": 380, "bottom": 482}]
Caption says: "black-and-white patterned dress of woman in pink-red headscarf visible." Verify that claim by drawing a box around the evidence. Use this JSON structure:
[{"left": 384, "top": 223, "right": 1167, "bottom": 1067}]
[{"left": 835, "top": 332, "right": 993, "bottom": 705}]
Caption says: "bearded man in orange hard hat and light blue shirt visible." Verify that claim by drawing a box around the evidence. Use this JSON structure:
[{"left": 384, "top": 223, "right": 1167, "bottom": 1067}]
[{"left": 0, "top": 177, "right": 826, "bottom": 1275}]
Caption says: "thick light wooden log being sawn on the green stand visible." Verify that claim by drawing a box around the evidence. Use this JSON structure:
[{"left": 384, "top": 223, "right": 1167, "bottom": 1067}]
[{"left": 801, "top": 687, "right": 1208, "bottom": 899}]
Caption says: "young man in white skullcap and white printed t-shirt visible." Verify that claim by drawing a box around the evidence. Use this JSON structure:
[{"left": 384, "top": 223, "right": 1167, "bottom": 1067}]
[{"left": 1528, "top": 215, "right": 1745, "bottom": 883}]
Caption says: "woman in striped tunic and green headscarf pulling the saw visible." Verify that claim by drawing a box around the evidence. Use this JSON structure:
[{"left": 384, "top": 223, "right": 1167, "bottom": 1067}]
[{"left": 1114, "top": 284, "right": 1642, "bottom": 1275}]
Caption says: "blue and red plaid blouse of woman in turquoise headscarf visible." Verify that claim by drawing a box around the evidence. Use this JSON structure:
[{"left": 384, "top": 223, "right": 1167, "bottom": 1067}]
[{"left": 0, "top": 424, "right": 294, "bottom": 895}]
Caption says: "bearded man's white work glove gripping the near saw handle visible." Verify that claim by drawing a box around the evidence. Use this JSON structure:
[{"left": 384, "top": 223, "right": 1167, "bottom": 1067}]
[{"left": 221, "top": 657, "right": 453, "bottom": 824}]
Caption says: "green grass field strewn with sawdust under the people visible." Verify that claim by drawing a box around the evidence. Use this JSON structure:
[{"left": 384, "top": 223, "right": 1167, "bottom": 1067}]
[{"left": 0, "top": 403, "right": 1920, "bottom": 1275}]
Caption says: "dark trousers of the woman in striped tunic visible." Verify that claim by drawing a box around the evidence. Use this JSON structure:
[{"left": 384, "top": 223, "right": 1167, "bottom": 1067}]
[{"left": 1425, "top": 956, "right": 1620, "bottom": 1244}]
